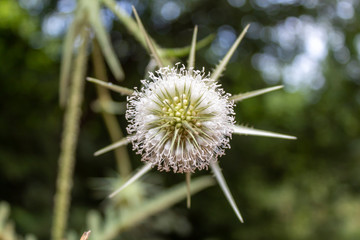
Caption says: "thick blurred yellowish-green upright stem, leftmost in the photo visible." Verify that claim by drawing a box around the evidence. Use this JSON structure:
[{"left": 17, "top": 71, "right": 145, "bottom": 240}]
[{"left": 51, "top": 26, "right": 89, "bottom": 240}]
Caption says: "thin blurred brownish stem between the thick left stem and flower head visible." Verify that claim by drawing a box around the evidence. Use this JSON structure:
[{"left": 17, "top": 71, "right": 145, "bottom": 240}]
[{"left": 92, "top": 40, "right": 131, "bottom": 178}]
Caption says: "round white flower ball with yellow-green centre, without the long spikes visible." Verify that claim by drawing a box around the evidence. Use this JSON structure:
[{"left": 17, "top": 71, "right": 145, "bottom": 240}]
[{"left": 126, "top": 64, "right": 235, "bottom": 173}]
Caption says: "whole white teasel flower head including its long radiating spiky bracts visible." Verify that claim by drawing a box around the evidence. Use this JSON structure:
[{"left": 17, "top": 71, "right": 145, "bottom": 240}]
[{"left": 88, "top": 8, "right": 296, "bottom": 222}]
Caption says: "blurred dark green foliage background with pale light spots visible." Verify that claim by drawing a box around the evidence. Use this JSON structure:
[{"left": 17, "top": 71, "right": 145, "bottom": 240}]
[{"left": 0, "top": 0, "right": 360, "bottom": 240}]
